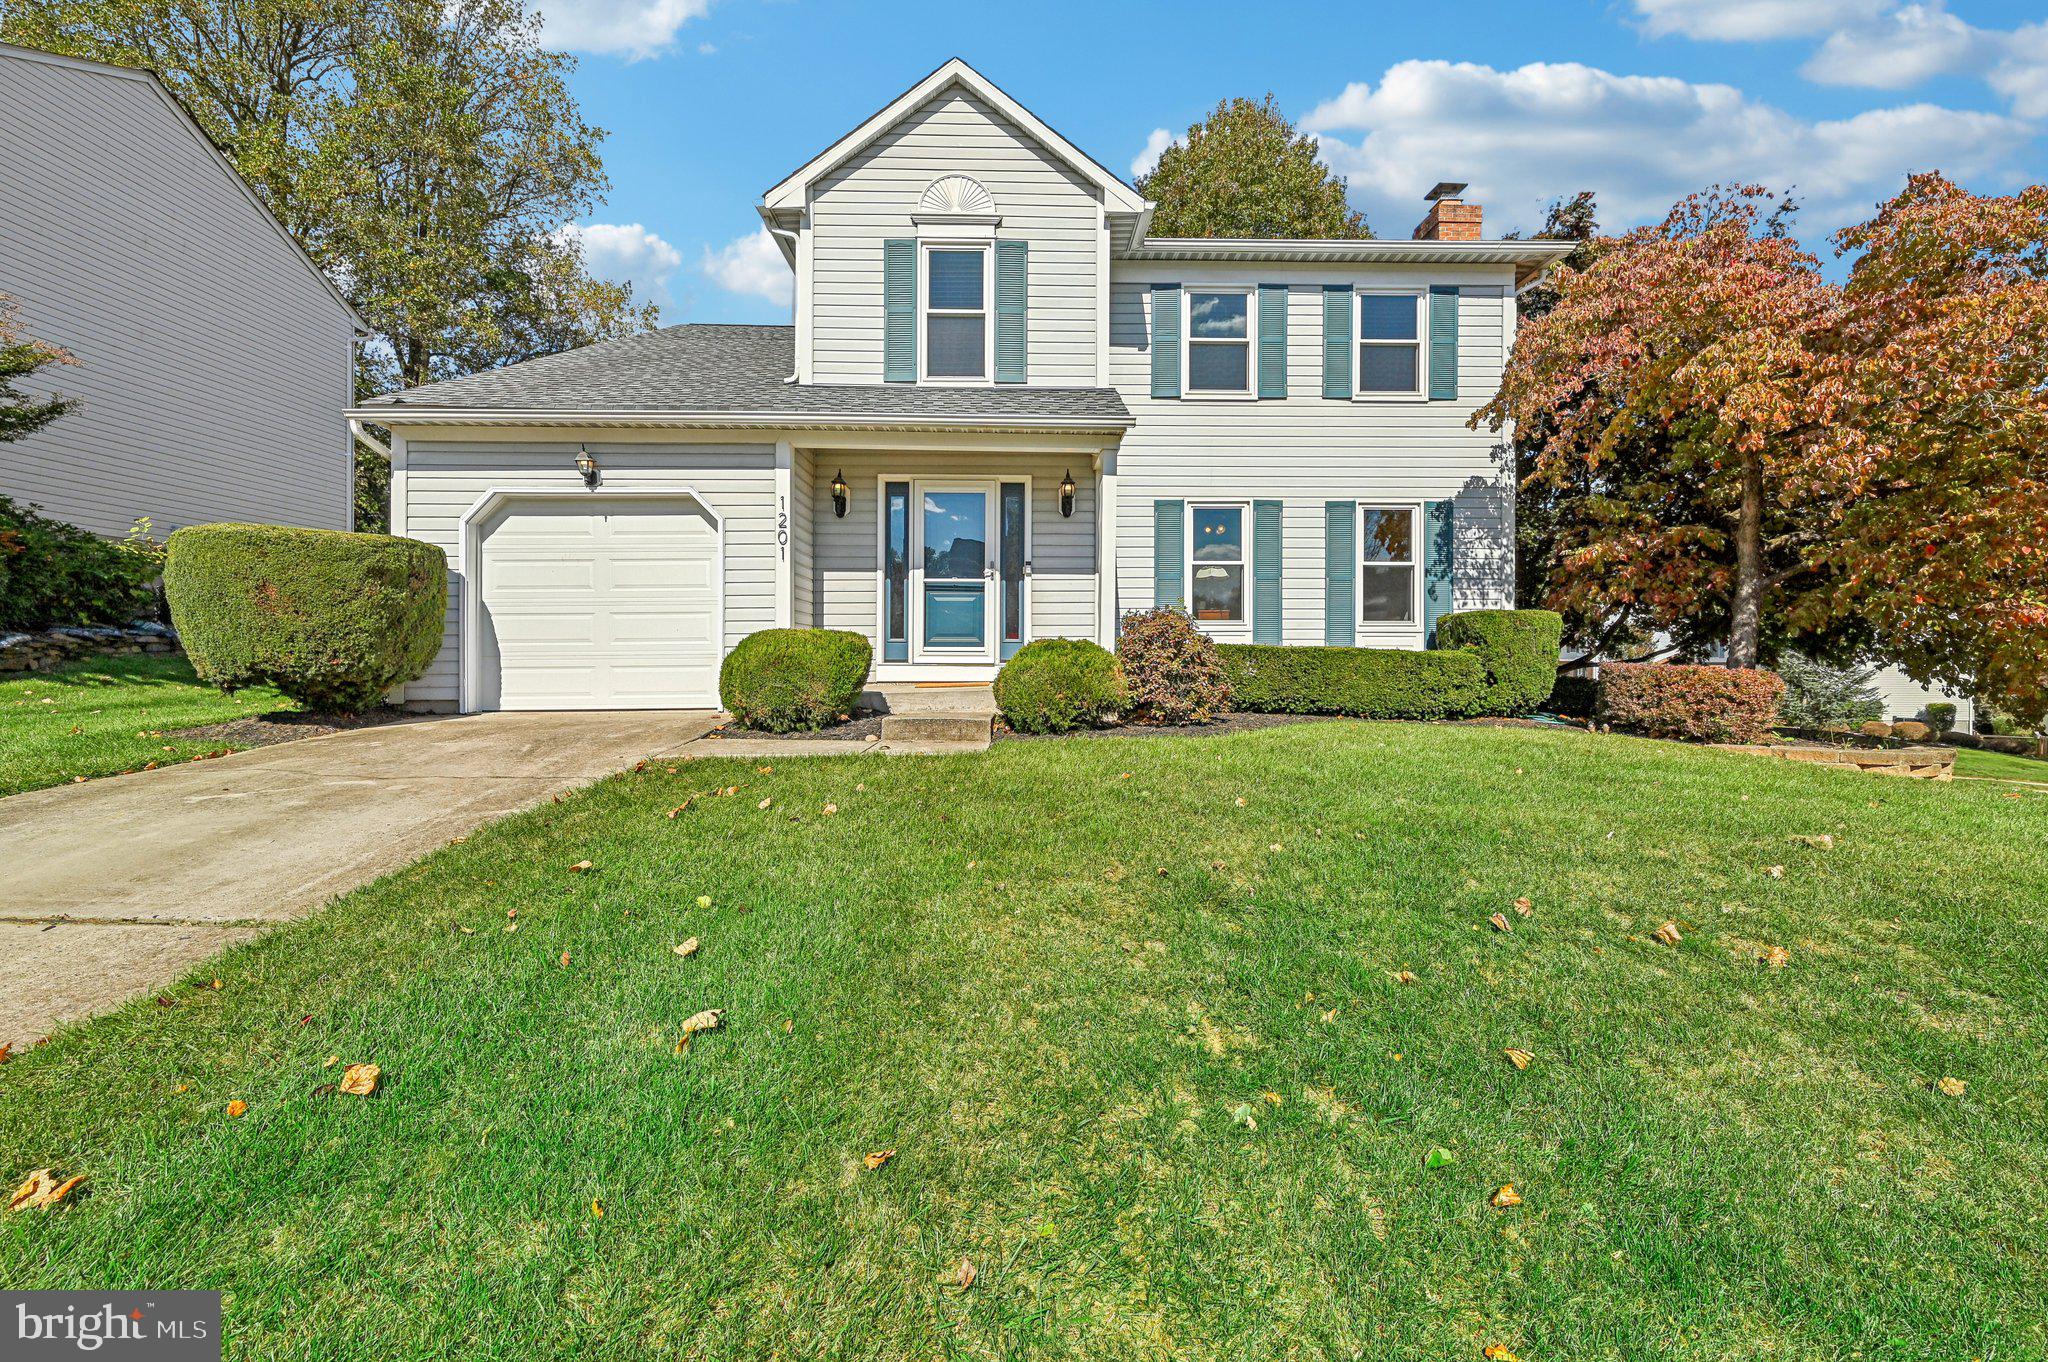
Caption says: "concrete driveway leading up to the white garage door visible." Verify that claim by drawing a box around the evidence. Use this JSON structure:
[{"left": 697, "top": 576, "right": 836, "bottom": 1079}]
[{"left": 0, "top": 711, "right": 719, "bottom": 1049}]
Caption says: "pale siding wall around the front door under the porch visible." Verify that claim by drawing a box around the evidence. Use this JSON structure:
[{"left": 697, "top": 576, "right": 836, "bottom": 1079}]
[{"left": 799, "top": 451, "right": 1096, "bottom": 655}]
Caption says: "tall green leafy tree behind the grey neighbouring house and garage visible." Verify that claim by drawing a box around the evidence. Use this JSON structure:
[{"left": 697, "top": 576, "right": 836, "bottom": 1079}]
[{"left": 0, "top": 0, "right": 657, "bottom": 528}]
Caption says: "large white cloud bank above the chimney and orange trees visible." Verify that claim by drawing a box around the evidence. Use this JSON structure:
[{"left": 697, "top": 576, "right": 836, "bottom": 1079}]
[{"left": 1303, "top": 61, "right": 2032, "bottom": 236}]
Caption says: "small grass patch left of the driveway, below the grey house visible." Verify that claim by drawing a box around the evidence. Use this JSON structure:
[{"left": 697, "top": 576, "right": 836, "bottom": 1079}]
[{"left": 0, "top": 655, "right": 295, "bottom": 795}]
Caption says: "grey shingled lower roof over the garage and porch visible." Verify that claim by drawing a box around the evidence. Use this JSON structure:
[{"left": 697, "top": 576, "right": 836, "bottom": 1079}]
[{"left": 352, "top": 324, "right": 1133, "bottom": 430}]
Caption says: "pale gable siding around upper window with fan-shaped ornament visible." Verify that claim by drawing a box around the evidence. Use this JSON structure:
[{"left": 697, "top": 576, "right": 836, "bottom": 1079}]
[{"left": 807, "top": 86, "right": 1102, "bottom": 387}]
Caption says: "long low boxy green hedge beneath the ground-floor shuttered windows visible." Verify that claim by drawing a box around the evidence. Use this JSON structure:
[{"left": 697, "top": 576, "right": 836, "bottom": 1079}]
[{"left": 1217, "top": 643, "right": 1487, "bottom": 719}]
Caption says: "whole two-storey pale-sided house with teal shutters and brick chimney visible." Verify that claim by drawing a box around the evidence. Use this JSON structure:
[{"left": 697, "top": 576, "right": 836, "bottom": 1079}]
[{"left": 354, "top": 61, "right": 1571, "bottom": 711}]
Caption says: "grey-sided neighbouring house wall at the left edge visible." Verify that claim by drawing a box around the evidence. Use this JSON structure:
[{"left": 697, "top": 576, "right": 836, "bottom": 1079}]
[{"left": 0, "top": 43, "right": 362, "bottom": 535}]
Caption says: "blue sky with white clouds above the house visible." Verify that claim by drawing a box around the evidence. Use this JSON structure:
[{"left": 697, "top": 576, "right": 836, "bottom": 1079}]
[{"left": 539, "top": 0, "right": 2048, "bottom": 322}]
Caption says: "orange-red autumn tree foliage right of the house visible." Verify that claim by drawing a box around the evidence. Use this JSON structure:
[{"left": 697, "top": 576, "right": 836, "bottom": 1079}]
[{"left": 1475, "top": 176, "right": 2048, "bottom": 717}]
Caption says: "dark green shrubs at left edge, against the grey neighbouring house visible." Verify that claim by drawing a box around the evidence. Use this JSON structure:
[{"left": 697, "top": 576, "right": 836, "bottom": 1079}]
[{"left": 0, "top": 496, "right": 158, "bottom": 633}]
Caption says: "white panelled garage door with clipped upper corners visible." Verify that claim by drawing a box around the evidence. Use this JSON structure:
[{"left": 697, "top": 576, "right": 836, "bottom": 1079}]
[{"left": 477, "top": 496, "right": 721, "bottom": 709}]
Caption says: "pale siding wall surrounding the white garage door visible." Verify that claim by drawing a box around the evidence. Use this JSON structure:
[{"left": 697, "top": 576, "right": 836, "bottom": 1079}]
[{"left": 391, "top": 428, "right": 774, "bottom": 711}]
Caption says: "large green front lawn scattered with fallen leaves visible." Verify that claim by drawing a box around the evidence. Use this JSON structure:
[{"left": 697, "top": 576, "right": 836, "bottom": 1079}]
[{"left": 0, "top": 723, "right": 2048, "bottom": 1362}]
